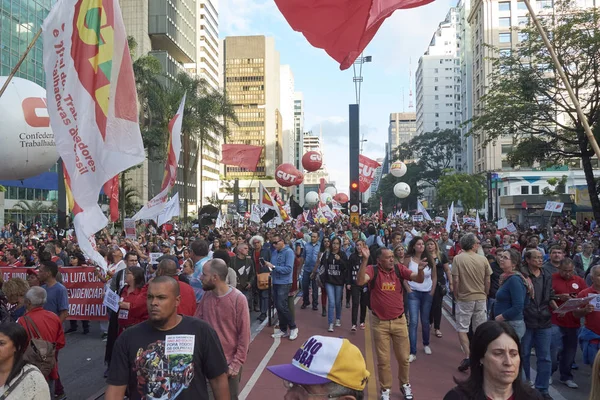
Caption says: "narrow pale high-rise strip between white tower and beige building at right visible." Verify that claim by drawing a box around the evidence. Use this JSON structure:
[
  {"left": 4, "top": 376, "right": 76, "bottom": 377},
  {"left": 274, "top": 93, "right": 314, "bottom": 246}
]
[{"left": 456, "top": 0, "right": 473, "bottom": 174}]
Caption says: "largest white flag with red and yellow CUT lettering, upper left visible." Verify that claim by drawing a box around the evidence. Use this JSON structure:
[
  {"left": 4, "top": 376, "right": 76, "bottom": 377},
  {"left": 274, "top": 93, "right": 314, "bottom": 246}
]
[{"left": 42, "top": 0, "right": 145, "bottom": 267}]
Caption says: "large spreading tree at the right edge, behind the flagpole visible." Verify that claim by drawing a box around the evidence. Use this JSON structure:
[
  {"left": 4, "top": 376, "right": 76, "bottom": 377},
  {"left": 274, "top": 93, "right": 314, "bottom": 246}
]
[{"left": 470, "top": 0, "right": 600, "bottom": 220}]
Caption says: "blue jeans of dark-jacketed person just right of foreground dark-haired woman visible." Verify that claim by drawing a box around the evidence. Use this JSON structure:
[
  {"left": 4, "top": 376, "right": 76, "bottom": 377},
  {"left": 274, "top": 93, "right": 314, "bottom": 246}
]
[{"left": 521, "top": 328, "right": 552, "bottom": 393}]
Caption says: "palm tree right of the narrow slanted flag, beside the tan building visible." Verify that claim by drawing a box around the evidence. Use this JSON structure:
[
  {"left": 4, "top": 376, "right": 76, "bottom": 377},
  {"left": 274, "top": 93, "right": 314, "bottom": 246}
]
[{"left": 168, "top": 72, "right": 237, "bottom": 223}]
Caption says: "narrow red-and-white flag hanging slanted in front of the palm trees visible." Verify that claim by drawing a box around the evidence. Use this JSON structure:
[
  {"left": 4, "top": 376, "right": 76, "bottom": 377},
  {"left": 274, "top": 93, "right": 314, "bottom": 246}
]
[{"left": 133, "top": 94, "right": 185, "bottom": 221}]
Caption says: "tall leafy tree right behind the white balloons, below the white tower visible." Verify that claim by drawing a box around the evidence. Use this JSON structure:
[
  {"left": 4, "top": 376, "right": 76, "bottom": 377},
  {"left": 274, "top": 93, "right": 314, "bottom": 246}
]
[{"left": 397, "top": 129, "right": 460, "bottom": 186}]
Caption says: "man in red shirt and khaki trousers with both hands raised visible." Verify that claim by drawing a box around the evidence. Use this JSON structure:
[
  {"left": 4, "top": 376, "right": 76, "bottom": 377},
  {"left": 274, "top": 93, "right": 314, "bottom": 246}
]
[{"left": 356, "top": 246, "right": 427, "bottom": 400}]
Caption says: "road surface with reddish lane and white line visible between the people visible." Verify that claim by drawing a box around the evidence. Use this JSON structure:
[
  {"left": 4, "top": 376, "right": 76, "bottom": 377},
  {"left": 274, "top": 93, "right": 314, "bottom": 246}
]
[{"left": 59, "top": 296, "right": 591, "bottom": 400}]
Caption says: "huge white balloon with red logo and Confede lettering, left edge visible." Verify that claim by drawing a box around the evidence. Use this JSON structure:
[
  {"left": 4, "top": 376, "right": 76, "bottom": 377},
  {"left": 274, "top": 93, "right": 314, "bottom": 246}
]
[{"left": 0, "top": 76, "right": 58, "bottom": 180}]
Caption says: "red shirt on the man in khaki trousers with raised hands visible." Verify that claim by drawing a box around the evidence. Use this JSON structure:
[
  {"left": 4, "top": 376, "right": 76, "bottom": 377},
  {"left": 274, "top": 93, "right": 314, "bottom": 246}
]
[{"left": 366, "top": 264, "right": 411, "bottom": 320}]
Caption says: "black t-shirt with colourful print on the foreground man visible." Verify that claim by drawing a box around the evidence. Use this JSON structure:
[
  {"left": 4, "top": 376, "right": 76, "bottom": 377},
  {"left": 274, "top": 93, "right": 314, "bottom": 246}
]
[{"left": 106, "top": 316, "right": 228, "bottom": 400}]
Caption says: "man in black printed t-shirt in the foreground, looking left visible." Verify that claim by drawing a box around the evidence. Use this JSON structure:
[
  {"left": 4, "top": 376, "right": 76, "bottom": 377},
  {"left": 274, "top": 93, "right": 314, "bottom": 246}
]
[{"left": 105, "top": 276, "right": 229, "bottom": 400}]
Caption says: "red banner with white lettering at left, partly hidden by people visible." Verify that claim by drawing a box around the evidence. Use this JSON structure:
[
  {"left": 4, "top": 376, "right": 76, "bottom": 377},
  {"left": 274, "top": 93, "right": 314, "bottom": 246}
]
[{"left": 0, "top": 267, "right": 108, "bottom": 321}]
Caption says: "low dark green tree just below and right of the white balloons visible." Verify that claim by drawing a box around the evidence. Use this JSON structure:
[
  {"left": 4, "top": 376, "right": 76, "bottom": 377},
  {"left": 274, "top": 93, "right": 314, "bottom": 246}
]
[{"left": 436, "top": 174, "right": 487, "bottom": 213}]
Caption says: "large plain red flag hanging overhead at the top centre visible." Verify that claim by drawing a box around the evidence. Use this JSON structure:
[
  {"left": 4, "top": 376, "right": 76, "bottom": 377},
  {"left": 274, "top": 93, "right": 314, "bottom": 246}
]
[{"left": 275, "top": 0, "right": 433, "bottom": 69}]
